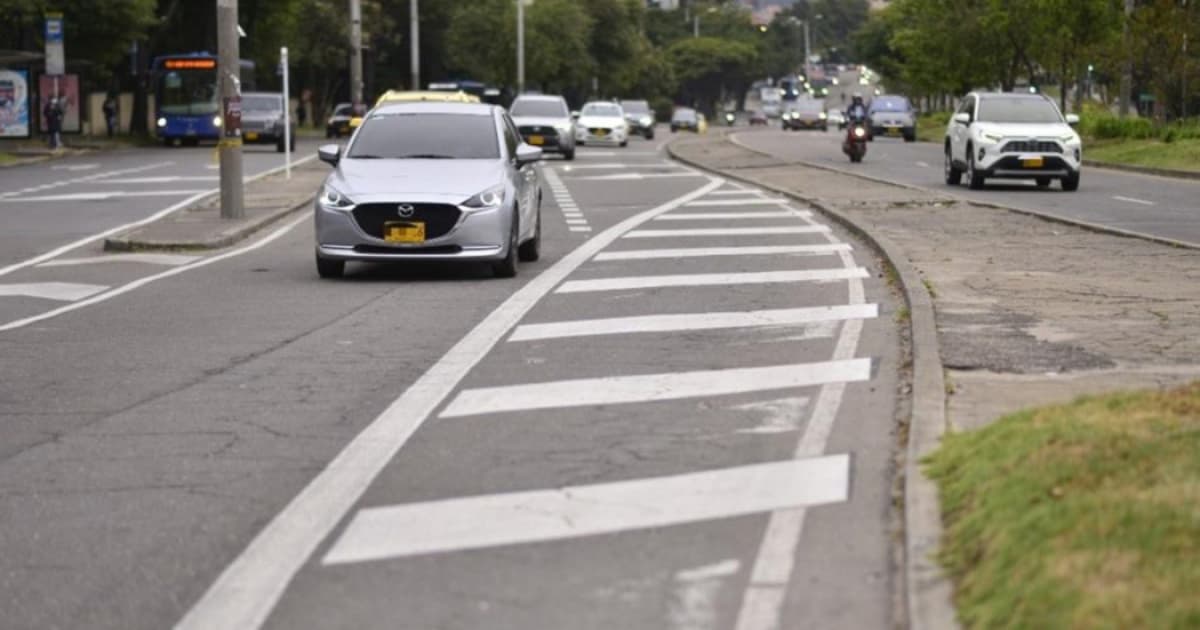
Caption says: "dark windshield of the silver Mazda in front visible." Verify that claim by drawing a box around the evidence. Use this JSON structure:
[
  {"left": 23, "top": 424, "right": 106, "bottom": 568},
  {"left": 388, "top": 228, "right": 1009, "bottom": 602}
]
[{"left": 346, "top": 113, "right": 500, "bottom": 160}]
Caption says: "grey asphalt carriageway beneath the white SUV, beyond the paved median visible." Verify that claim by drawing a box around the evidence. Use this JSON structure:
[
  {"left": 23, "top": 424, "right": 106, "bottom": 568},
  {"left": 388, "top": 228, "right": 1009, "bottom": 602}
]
[{"left": 734, "top": 111, "right": 1200, "bottom": 246}]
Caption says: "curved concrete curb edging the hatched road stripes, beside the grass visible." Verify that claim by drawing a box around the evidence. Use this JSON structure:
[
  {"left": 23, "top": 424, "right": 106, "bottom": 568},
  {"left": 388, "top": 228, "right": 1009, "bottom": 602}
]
[{"left": 667, "top": 138, "right": 959, "bottom": 630}]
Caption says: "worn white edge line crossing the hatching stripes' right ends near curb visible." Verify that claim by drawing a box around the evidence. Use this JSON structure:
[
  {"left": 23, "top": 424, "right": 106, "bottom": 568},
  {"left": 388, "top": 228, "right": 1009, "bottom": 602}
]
[{"left": 734, "top": 208, "right": 866, "bottom": 630}]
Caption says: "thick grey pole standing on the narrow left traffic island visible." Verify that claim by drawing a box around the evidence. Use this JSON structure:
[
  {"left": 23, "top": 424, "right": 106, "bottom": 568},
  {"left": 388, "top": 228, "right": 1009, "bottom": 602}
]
[{"left": 217, "top": 0, "right": 246, "bottom": 218}]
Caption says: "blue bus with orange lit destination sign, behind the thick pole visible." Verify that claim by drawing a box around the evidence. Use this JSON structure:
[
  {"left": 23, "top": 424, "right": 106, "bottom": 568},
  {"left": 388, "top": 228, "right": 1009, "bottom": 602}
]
[{"left": 152, "top": 53, "right": 254, "bottom": 146}]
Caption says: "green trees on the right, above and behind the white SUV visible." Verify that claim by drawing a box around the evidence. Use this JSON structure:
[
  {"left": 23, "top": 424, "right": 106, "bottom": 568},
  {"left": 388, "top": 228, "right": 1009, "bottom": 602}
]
[{"left": 854, "top": 0, "right": 1200, "bottom": 119}]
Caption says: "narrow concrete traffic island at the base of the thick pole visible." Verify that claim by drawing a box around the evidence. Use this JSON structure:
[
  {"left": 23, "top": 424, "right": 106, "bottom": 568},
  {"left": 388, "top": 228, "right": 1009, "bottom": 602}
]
[{"left": 104, "top": 160, "right": 329, "bottom": 252}]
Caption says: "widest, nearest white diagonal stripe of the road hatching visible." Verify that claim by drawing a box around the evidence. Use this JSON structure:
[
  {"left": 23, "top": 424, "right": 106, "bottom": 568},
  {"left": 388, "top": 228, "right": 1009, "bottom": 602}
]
[{"left": 322, "top": 455, "right": 850, "bottom": 565}]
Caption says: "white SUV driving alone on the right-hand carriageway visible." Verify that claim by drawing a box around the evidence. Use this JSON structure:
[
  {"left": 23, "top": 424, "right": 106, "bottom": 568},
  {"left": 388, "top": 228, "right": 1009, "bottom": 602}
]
[{"left": 946, "top": 92, "right": 1084, "bottom": 191}]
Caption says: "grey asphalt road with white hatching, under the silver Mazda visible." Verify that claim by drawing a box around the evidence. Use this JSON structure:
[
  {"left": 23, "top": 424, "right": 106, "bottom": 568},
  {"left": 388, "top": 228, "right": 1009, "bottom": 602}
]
[{"left": 0, "top": 134, "right": 900, "bottom": 630}]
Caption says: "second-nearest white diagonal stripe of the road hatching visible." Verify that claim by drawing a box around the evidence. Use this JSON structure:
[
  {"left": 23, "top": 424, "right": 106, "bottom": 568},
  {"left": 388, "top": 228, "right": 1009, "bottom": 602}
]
[{"left": 438, "top": 359, "right": 871, "bottom": 418}]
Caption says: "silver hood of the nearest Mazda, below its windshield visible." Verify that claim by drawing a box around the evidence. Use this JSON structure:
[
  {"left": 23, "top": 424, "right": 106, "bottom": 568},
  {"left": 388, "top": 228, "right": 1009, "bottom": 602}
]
[{"left": 329, "top": 158, "right": 504, "bottom": 204}]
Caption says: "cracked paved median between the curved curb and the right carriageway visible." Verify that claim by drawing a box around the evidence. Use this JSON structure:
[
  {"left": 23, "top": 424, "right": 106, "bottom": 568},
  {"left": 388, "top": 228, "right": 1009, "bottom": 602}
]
[{"left": 670, "top": 133, "right": 1200, "bottom": 628}]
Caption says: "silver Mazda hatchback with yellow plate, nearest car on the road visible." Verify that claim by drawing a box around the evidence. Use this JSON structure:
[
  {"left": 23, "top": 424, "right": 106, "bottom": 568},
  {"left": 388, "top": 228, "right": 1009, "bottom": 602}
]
[{"left": 316, "top": 102, "right": 541, "bottom": 277}]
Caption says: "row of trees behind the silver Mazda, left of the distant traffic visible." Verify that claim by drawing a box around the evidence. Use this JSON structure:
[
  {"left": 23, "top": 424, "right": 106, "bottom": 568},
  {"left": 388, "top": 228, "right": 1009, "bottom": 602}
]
[{"left": 0, "top": 0, "right": 868, "bottom": 132}]
